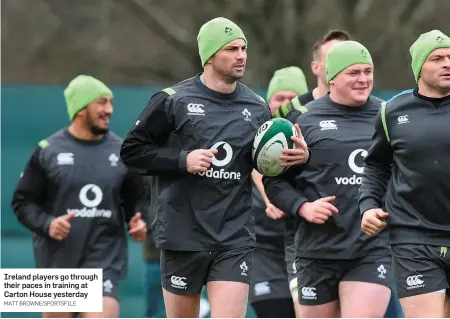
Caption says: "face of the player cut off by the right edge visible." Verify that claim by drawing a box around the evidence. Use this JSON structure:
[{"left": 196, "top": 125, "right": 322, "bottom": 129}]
[{"left": 420, "top": 48, "right": 450, "bottom": 94}]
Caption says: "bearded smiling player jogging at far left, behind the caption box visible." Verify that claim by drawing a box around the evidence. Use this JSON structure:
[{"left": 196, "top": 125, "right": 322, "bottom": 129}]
[{"left": 12, "top": 75, "right": 147, "bottom": 318}]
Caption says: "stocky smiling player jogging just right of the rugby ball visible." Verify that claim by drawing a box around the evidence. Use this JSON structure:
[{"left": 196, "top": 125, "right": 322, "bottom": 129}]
[{"left": 264, "top": 41, "right": 391, "bottom": 317}]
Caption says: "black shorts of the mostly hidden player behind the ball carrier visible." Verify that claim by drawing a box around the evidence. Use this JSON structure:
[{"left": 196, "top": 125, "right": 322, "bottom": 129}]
[{"left": 249, "top": 247, "right": 291, "bottom": 303}]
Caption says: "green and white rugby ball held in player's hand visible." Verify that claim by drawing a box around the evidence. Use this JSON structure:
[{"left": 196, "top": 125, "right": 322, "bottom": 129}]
[{"left": 252, "top": 118, "right": 298, "bottom": 176}]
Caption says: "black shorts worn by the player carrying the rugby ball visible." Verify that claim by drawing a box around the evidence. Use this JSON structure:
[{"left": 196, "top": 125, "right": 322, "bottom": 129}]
[{"left": 161, "top": 247, "right": 254, "bottom": 295}]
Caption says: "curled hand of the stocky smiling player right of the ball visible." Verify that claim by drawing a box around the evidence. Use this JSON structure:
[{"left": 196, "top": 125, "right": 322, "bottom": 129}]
[{"left": 298, "top": 196, "right": 339, "bottom": 224}]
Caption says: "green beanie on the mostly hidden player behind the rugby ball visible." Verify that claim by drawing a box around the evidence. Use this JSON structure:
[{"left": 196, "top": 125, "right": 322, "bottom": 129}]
[{"left": 267, "top": 66, "right": 308, "bottom": 103}]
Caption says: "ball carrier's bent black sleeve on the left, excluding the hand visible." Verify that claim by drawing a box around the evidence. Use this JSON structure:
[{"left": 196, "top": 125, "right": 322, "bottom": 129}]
[{"left": 120, "top": 91, "right": 188, "bottom": 175}]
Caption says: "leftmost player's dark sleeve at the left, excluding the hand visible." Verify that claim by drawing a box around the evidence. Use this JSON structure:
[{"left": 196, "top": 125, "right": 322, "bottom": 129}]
[{"left": 11, "top": 147, "right": 54, "bottom": 238}]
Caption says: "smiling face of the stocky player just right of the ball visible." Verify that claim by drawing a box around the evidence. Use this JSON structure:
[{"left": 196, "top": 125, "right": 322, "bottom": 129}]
[{"left": 332, "top": 64, "right": 373, "bottom": 106}]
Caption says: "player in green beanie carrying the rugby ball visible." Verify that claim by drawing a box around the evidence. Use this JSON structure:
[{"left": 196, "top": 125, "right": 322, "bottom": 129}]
[{"left": 121, "top": 18, "right": 309, "bottom": 317}]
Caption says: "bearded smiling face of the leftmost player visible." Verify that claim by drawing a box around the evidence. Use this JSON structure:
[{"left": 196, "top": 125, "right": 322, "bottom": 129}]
[{"left": 85, "top": 95, "right": 113, "bottom": 135}]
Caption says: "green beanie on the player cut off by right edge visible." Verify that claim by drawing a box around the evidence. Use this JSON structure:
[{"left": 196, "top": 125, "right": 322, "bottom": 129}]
[{"left": 409, "top": 30, "right": 450, "bottom": 82}]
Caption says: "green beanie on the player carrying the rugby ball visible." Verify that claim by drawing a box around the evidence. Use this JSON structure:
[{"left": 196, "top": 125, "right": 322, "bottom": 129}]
[{"left": 197, "top": 17, "right": 247, "bottom": 66}]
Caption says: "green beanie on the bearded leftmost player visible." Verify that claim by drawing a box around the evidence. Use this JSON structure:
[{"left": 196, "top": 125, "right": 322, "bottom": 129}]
[{"left": 64, "top": 75, "right": 113, "bottom": 121}]
